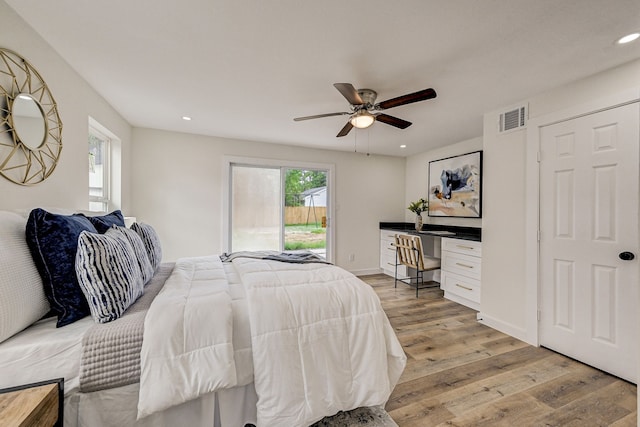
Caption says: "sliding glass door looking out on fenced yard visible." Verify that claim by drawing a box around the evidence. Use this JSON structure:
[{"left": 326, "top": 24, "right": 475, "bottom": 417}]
[{"left": 229, "top": 163, "right": 331, "bottom": 259}]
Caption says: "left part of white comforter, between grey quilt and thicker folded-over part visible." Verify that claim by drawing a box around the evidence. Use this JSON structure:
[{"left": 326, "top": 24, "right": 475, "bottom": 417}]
[{"left": 138, "top": 257, "right": 238, "bottom": 418}]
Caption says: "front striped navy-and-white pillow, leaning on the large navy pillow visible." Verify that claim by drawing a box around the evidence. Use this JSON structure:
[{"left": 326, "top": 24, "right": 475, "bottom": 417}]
[{"left": 76, "top": 229, "right": 144, "bottom": 323}]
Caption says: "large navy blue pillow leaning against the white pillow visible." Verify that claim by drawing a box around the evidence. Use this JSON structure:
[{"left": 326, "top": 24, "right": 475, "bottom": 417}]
[{"left": 25, "top": 209, "right": 98, "bottom": 327}]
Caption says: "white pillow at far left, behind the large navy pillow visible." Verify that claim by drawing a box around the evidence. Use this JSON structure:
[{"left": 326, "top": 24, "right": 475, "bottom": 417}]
[{"left": 0, "top": 211, "right": 49, "bottom": 342}]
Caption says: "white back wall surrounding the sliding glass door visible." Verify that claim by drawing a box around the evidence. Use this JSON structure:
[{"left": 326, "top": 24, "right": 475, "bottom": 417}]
[{"left": 132, "top": 128, "right": 405, "bottom": 272}]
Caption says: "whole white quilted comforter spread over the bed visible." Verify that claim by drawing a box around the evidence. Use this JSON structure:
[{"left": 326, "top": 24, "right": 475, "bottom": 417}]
[{"left": 138, "top": 256, "right": 406, "bottom": 427}]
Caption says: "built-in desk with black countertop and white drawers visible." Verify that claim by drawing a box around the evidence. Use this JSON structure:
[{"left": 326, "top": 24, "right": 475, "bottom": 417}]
[{"left": 380, "top": 222, "right": 482, "bottom": 310}]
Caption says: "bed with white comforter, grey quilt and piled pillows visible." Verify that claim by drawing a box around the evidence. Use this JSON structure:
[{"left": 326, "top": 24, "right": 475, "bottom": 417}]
[{"left": 0, "top": 211, "right": 406, "bottom": 427}]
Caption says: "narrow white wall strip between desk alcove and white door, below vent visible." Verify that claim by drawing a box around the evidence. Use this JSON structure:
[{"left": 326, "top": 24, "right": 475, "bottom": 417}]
[{"left": 480, "top": 124, "right": 526, "bottom": 339}]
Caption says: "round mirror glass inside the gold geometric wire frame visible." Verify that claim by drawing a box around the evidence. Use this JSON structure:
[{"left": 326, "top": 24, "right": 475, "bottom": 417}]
[{"left": 11, "top": 93, "right": 47, "bottom": 150}]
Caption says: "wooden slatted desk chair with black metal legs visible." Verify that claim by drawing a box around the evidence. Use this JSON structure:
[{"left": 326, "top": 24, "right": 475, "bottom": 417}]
[{"left": 393, "top": 234, "right": 440, "bottom": 298}]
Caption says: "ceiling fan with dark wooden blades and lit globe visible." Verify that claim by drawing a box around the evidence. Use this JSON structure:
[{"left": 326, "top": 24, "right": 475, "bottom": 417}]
[{"left": 293, "top": 83, "right": 436, "bottom": 137}]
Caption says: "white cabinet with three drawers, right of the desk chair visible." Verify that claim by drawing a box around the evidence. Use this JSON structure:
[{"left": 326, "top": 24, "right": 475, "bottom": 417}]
[{"left": 440, "top": 238, "right": 482, "bottom": 310}]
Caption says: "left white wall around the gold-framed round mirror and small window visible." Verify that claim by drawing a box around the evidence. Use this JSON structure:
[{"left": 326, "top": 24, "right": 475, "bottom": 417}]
[{"left": 0, "top": 0, "right": 131, "bottom": 213}]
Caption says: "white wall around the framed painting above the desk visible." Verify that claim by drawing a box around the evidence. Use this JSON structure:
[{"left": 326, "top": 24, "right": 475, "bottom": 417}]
[{"left": 404, "top": 137, "right": 484, "bottom": 227}]
